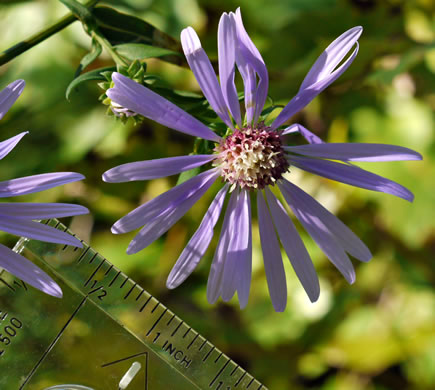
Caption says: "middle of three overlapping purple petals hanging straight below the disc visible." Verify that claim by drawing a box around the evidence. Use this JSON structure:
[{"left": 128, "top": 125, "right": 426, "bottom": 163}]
[{"left": 221, "top": 190, "right": 251, "bottom": 301}]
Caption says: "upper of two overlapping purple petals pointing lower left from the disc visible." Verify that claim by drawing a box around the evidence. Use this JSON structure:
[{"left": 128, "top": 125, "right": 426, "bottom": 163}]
[{"left": 112, "top": 169, "right": 219, "bottom": 234}]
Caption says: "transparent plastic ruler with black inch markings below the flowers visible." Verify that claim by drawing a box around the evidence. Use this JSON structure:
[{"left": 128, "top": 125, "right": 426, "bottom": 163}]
[{"left": 0, "top": 220, "right": 267, "bottom": 390}]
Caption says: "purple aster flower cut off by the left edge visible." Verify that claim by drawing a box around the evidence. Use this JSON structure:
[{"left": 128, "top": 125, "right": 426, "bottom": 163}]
[{"left": 0, "top": 80, "right": 89, "bottom": 297}]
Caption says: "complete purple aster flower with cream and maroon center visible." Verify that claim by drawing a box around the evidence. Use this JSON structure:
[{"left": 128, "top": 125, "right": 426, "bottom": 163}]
[{"left": 103, "top": 10, "right": 421, "bottom": 311}]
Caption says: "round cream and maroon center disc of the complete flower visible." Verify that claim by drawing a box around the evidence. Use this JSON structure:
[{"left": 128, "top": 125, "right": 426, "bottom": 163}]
[{"left": 215, "top": 124, "right": 289, "bottom": 190}]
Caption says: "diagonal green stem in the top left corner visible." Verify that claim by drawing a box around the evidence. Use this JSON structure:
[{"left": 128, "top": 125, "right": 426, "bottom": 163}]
[{"left": 0, "top": 0, "right": 99, "bottom": 66}]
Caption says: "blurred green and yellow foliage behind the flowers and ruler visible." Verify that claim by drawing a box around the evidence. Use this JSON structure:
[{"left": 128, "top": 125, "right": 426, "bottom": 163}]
[{"left": 0, "top": 0, "right": 435, "bottom": 390}]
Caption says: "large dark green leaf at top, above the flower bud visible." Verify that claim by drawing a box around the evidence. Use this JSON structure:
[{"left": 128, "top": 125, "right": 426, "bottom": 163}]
[{"left": 92, "top": 6, "right": 186, "bottom": 65}]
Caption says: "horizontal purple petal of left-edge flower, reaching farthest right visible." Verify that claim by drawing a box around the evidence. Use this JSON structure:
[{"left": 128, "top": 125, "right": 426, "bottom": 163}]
[{"left": 0, "top": 203, "right": 89, "bottom": 219}]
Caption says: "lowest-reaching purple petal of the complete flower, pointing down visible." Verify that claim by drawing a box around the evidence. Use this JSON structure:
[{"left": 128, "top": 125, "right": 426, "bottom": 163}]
[{"left": 257, "top": 191, "right": 287, "bottom": 312}]
